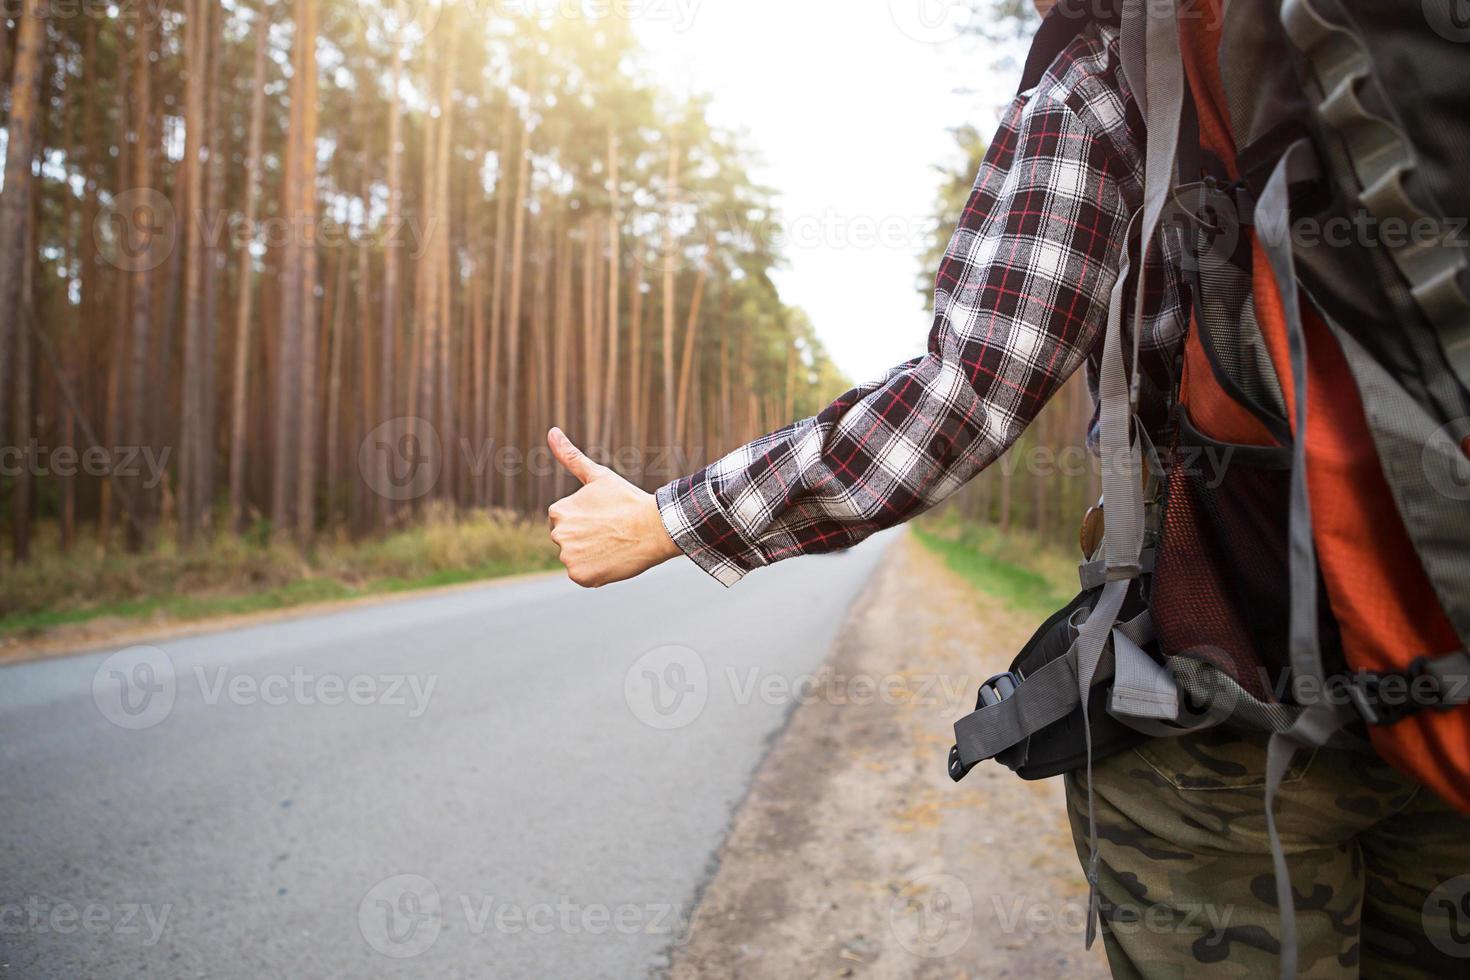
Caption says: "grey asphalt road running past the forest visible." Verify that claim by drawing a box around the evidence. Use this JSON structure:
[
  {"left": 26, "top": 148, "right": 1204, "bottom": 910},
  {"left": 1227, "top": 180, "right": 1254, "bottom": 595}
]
[{"left": 0, "top": 539, "right": 886, "bottom": 980}]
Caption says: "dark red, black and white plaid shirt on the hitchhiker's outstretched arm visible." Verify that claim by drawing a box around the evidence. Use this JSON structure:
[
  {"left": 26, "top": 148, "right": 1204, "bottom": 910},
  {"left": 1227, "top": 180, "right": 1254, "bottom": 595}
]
[{"left": 659, "top": 25, "right": 1188, "bottom": 585}]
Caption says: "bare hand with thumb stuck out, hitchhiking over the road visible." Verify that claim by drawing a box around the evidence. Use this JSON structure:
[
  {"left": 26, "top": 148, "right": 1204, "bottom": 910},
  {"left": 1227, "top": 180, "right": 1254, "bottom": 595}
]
[{"left": 547, "top": 429, "right": 684, "bottom": 589}]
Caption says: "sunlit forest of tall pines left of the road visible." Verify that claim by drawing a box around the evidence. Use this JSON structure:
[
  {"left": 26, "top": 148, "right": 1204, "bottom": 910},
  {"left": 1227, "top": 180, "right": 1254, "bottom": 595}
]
[{"left": 0, "top": 0, "right": 845, "bottom": 561}]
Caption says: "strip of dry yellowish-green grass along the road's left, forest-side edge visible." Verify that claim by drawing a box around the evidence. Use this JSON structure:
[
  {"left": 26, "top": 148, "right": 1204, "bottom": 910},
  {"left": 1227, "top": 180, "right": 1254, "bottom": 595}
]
[{"left": 0, "top": 508, "right": 556, "bottom": 641}]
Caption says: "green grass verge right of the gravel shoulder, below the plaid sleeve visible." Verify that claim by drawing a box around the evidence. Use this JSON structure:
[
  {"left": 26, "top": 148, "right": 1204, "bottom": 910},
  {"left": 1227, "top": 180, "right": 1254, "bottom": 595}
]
[{"left": 914, "top": 513, "right": 1078, "bottom": 616}]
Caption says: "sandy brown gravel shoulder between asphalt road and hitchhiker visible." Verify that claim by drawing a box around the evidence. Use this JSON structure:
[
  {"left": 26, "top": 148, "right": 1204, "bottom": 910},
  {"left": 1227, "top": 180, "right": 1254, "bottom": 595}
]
[{"left": 670, "top": 536, "right": 1108, "bottom": 980}]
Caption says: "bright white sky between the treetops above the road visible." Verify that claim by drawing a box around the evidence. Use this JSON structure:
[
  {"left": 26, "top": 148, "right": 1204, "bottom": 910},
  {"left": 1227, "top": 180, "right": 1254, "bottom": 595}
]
[{"left": 632, "top": 0, "right": 1016, "bottom": 381}]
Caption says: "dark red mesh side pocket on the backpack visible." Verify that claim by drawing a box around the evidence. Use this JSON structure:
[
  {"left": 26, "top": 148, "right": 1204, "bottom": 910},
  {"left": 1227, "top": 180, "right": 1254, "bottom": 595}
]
[{"left": 1150, "top": 413, "right": 1291, "bottom": 701}]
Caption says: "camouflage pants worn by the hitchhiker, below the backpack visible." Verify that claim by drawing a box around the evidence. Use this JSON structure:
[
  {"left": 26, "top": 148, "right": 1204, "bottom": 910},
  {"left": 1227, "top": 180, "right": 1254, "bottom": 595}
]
[{"left": 1067, "top": 730, "right": 1470, "bottom": 980}]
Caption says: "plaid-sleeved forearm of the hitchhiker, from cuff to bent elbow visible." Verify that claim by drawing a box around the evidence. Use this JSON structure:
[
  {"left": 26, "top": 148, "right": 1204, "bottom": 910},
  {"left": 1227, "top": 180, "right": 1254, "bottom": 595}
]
[{"left": 657, "top": 337, "right": 1082, "bottom": 585}]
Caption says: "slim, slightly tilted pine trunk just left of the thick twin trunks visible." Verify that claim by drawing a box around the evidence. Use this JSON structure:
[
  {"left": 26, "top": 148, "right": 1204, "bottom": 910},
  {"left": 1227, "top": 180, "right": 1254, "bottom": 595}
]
[{"left": 229, "top": 3, "right": 269, "bottom": 530}]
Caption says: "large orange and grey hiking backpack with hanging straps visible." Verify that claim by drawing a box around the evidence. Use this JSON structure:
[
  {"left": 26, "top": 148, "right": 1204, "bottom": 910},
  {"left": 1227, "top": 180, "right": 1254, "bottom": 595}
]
[{"left": 950, "top": 0, "right": 1470, "bottom": 976}]
